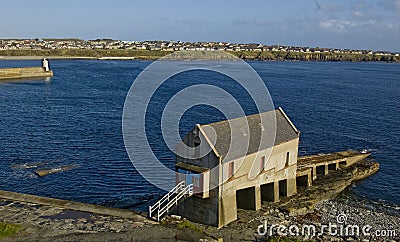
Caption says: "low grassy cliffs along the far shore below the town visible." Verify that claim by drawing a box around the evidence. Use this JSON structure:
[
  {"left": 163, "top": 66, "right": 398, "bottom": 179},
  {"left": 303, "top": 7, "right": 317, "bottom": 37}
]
[{"left": 0, "top": 49, "right": 400, "bottom": 63}]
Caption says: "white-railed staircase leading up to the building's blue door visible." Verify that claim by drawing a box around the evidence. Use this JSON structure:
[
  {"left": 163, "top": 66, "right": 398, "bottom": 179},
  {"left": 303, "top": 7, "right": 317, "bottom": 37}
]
[{"left": 149, "top": 181, "right": 193, "bottom": 221}]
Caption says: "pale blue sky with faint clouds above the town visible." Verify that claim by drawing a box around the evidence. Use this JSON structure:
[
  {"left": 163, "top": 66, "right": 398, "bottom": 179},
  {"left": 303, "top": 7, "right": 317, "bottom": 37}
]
[{"left": 0, "top": 0, "right": 400, "bottom": 52}]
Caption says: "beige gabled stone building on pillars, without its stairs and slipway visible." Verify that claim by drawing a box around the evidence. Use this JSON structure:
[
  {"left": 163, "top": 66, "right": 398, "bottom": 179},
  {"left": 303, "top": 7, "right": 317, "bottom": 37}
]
[{"left": 175, "top": 108, "right": 300, "bottom": 228}]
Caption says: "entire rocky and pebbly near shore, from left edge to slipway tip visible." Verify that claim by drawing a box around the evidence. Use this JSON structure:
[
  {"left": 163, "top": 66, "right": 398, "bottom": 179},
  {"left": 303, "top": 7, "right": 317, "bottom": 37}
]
[{"left": 0, "top": 160, "right": 400, "bottom": 241}]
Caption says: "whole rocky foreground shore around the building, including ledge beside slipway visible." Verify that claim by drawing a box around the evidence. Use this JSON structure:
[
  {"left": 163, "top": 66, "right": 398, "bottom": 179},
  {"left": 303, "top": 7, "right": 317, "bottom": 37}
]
[{"left": 0, "top": 156, "right": 400, "bottom": 241}]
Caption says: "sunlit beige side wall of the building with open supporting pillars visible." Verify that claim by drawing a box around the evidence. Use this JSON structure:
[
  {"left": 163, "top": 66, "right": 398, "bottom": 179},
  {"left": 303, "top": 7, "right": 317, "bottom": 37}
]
[{"left": 218, "top": 138, "right": 299, "bottom": 227}]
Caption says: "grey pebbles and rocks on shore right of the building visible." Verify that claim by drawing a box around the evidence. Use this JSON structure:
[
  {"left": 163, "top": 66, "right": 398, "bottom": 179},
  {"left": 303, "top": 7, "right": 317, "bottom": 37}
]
[{"left": 192, "top": 195, "right": 400, "bottom": 241}]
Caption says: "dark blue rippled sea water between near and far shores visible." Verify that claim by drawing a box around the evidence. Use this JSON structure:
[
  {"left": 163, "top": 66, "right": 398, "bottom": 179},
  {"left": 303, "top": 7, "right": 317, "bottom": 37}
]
[{"left": 0, "top": 60, "right": 400, "bottom": 208}]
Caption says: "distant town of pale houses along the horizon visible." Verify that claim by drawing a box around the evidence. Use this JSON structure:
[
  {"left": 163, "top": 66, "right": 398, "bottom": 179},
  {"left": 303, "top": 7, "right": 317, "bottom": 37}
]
[{"left": 0, "top": 38, "right": 399, "bottom": 57}]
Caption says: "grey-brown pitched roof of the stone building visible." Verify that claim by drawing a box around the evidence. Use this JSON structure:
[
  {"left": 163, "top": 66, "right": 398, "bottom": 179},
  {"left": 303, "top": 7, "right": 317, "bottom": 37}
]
[{"left": 199, "top": 108, "right": 300, "bottom": 161}]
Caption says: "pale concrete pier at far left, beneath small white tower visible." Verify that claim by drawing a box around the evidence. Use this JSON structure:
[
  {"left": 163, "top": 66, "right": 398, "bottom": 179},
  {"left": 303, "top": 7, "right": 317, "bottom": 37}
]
[{"left": 0, "top": 67, "right": 53, "bottom": 80}]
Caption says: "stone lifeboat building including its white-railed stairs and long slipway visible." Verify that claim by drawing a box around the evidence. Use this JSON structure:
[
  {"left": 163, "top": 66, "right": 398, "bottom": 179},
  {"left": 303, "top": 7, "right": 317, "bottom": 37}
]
[{"left": 149, "top": 108, "right": 370, "bottom": 228}]
